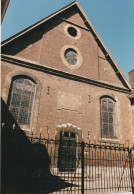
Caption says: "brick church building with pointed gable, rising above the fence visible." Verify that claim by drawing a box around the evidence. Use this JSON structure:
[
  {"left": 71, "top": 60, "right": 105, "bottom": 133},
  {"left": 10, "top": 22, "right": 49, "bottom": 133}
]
[{"left": 1, "top": 2, "right": 134, "bottom": 146}]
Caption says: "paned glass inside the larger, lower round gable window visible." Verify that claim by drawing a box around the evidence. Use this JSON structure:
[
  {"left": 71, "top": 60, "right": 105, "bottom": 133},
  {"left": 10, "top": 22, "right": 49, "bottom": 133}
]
[{"left": 64, "top": 48, "right": 77, "bottom": 65}]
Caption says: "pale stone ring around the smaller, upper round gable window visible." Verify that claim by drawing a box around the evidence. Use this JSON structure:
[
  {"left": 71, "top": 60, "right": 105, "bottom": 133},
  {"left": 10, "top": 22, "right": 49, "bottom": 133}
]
[{"left": 64, "top": 24, "right": 81, "bottom": 40}]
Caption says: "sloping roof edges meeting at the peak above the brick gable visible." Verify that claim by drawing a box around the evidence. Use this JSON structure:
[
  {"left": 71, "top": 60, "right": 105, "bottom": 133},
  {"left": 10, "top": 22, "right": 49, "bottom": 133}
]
[{"left": 1, "top": 1, "right": 131, "bottom": 90}]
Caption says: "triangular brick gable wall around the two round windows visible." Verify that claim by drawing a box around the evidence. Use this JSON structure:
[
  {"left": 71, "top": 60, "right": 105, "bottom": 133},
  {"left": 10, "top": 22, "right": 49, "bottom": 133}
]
[{"left": 1, "top": 10, "right": 122, "bottom": 86}]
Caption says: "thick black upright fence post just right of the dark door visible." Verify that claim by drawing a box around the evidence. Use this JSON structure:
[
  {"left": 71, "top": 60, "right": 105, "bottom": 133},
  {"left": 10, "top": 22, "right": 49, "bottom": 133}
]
[{"left": 81, "top": 142, "right": 84, "bottom": 194}]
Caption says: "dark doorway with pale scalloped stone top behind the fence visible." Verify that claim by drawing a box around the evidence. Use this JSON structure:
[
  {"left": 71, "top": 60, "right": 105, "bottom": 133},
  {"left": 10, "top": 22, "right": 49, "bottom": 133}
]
[{"left": 55, "top": 123, "right": 82, "bottom": 172}]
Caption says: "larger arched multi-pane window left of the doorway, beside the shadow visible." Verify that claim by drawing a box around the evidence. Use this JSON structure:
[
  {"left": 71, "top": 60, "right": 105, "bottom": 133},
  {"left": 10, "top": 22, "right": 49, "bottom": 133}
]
[{"left": 8, "top": 76, "right": 36, "bottom": 128}]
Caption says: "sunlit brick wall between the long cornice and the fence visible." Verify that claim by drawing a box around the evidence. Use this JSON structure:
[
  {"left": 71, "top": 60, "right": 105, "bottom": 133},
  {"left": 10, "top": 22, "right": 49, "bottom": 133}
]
[{"left": 2, "top": 62, "right": 133, "bottom": 146}]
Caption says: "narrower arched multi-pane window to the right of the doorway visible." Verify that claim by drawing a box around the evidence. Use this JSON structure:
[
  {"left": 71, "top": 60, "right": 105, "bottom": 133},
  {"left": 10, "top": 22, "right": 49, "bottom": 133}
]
[{"left": 101, "top": 96, "right": 117, "bottom": 139}]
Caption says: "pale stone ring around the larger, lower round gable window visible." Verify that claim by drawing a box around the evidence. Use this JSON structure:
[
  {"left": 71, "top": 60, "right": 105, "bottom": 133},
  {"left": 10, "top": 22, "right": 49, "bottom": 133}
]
[{"left": 61, "top": 45, "right": 82, "bottom": 69}]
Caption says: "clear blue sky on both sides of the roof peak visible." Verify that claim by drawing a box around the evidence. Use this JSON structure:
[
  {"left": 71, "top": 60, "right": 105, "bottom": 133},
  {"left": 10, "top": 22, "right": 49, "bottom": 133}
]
[{"left": 1, "top": 0, "right": 134, "bottom": 79}]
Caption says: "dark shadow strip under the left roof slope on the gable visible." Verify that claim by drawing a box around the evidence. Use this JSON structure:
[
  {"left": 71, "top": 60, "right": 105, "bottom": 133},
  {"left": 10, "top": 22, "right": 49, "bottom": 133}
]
[{"left": 1, "top": 9, "right": 77, "bottom": 55}]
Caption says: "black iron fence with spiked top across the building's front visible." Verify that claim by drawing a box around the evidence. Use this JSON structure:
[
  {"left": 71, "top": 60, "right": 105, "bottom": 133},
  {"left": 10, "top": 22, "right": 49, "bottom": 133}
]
[{"left": 1, "top": 122, "right": 134, "bottom": 194}]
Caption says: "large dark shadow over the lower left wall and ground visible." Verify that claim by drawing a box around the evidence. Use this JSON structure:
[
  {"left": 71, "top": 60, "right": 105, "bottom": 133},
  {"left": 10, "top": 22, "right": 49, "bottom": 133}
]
[{"left": 1, "top": 100, "right": 76, "bottom": 194}]
